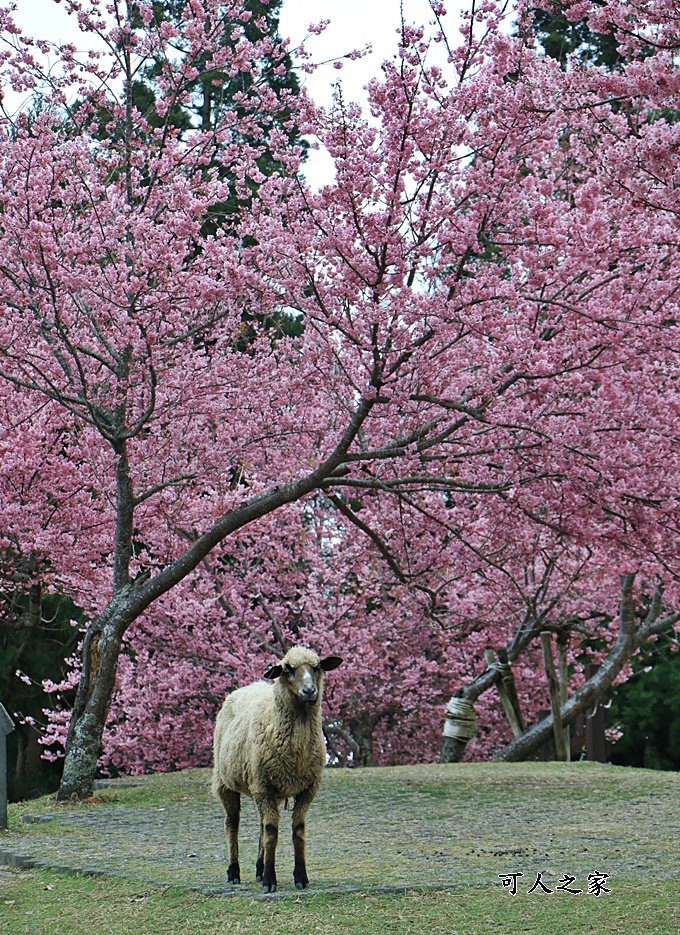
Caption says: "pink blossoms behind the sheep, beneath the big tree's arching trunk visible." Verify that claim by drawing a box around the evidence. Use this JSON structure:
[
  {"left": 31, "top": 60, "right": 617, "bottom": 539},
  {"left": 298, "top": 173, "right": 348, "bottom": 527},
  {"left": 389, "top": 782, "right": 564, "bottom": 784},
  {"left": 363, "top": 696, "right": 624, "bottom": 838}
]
[{"left": 93, "top": 482, "right": 677, "bottom": 772}]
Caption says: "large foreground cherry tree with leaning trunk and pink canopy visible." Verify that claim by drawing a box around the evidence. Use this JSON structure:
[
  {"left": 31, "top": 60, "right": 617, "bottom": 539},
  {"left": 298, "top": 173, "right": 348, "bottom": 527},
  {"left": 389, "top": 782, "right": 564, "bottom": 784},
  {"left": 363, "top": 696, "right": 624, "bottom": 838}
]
[{"left": 0, "top": 0, "right": 680, "bottom": 798}]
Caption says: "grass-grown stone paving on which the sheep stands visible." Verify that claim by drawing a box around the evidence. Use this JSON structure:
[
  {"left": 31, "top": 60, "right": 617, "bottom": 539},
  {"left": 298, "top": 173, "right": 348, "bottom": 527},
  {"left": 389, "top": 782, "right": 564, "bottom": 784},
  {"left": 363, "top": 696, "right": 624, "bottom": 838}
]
[{"left": 0, "top": 763, "right": 680, "bottom": 893}]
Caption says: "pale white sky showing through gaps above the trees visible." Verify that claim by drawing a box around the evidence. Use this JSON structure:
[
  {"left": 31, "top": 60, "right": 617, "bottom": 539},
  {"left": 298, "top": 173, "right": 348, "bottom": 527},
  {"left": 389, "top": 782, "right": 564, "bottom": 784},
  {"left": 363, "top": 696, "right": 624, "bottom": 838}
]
[{"left": 6, "top": 0, "right": 456, "bottom": 184}]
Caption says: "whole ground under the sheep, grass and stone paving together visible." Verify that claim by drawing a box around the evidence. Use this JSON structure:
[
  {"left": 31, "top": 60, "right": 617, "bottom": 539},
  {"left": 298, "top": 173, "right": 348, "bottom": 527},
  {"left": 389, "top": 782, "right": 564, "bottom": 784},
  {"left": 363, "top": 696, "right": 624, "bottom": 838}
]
[{"left": 0, "top": 763, "right": 680, "bottom": 935}]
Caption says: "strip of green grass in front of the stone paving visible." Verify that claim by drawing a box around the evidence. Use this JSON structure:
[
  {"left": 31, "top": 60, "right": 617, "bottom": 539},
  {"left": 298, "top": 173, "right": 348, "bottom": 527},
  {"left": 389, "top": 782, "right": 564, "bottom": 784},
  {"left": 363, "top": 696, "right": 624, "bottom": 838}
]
[{"left": 0, "top": 871, "right": 680, "bottom": 935}]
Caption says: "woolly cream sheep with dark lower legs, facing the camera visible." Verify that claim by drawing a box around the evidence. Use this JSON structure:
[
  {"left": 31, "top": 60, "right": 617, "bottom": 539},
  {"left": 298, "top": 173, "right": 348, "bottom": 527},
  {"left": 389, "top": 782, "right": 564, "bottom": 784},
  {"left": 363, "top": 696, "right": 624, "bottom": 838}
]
[{"left": 212, "top": 646, "right": 342, "bottom": 893}]
